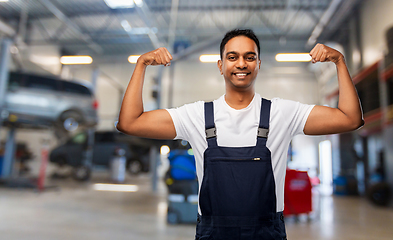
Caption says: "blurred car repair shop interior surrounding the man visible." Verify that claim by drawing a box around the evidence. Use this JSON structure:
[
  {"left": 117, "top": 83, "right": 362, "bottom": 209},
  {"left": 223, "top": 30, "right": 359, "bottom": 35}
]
[{"left": 0, "top": 0, "right": 393, "bottom": 240}]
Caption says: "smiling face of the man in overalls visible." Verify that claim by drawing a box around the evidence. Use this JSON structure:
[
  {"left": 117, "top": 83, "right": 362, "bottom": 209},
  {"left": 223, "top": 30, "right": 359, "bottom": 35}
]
[{"left": 217, "top": 36, "right": 261, "bottom": 90}]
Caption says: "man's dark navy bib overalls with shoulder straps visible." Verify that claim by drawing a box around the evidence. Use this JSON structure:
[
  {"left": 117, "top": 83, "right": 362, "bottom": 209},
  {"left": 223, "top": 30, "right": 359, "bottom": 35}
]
[{"left": 195, "top": 99, "right": 286, "bottom": 240}]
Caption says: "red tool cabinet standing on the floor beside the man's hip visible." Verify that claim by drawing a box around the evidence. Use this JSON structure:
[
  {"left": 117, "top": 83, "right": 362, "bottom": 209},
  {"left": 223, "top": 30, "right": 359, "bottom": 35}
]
[{"left": 284, "top": 169, "right": 312, "bottom": 215}]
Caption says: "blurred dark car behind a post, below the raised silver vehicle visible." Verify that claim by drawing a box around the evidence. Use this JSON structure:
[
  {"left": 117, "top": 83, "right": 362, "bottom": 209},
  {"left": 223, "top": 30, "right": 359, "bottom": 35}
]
[{"left": 49, "top": 131, "right": 154, "bottom": 181}]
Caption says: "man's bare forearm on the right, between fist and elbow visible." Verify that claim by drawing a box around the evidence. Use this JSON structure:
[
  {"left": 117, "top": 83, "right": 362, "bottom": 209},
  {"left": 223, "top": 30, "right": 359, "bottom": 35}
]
[{"left": 336, "top": 58, "right": 363, "bottom": 128}]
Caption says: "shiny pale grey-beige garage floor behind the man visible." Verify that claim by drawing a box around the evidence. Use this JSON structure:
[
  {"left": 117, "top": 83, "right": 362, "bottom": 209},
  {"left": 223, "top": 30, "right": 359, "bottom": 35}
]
[{"left": 0, "top": 172, "right": 393, "bottom": 240}]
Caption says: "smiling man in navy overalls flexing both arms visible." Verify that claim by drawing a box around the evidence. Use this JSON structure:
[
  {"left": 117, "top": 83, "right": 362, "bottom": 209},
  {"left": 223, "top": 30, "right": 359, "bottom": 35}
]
[{"left": 117, "top": 30, "right": 363, "bottom": 240}]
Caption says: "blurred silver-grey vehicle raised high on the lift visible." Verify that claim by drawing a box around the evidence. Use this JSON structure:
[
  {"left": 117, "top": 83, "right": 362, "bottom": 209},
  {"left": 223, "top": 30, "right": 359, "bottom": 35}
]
[{"left": 2, "top": 72, "right": 98, "bottom": 132}]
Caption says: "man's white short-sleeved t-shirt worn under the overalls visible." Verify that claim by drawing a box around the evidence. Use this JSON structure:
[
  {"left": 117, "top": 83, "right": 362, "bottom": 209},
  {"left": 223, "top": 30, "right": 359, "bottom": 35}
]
[{"left": 167, "top": 93, "right": 314, "bottom": 214}]
